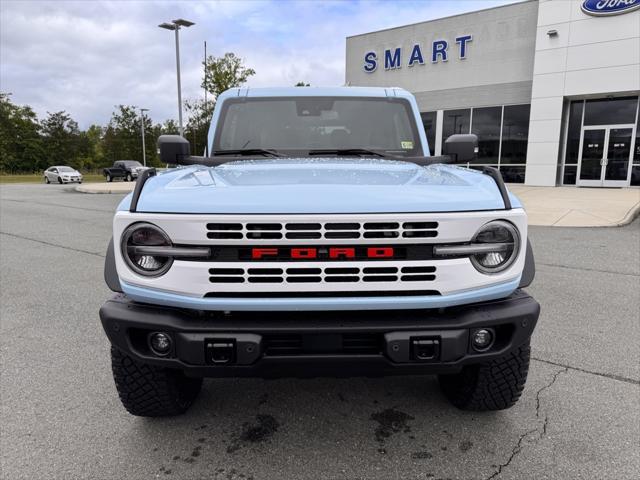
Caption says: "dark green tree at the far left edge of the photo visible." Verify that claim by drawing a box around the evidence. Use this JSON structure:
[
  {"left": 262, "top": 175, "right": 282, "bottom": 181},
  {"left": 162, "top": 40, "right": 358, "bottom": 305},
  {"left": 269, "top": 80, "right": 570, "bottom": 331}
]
[{"left": 0, "top": 93, "right": 49, "bottom": 173}]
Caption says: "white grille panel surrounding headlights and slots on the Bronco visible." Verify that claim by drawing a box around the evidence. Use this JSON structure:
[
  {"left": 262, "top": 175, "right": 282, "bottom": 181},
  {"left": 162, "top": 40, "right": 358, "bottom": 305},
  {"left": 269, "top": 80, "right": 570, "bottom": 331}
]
[{"left": 114, "top": 209, "right": 527, "bottom": 308}]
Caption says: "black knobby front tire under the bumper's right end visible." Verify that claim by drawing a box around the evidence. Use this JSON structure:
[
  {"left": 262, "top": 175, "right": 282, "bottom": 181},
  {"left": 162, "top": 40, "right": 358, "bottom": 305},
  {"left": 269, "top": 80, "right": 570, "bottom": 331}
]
[{"left": 438, "top": 341, "right": 531, "bottom": 411}]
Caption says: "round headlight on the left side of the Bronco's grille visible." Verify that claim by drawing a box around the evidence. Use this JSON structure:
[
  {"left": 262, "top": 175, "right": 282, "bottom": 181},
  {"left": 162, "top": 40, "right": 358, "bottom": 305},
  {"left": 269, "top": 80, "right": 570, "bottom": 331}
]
[{"left": 121, "top": 223, "right": 173, "bottom": 277}]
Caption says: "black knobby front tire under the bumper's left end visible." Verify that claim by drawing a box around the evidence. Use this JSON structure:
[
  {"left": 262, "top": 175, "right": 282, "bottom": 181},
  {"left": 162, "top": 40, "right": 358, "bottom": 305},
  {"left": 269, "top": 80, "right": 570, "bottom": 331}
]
[{"left": 111, "top": 347, "right": 202, "bottom": 417}]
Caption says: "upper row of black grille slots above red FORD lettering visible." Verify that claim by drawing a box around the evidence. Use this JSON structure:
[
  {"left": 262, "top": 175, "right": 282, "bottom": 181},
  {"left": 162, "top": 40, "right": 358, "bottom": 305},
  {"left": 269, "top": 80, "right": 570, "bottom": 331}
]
[{"left": 207, "top": 221, "right": 438, "bottom": 241}]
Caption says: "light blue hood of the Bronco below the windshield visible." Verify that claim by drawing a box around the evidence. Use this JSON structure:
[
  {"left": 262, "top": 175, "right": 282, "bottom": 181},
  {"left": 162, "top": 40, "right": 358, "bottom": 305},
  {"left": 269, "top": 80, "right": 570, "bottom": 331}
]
[{"left": 119, "top": 158, "right": 520, "bottom": 214}]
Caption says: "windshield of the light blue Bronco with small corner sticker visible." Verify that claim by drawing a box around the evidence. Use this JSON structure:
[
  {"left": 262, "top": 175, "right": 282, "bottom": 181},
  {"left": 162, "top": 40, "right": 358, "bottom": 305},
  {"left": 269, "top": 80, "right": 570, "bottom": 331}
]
[{"left": 213, "top": 97, "right": 421, "bottom": 155}]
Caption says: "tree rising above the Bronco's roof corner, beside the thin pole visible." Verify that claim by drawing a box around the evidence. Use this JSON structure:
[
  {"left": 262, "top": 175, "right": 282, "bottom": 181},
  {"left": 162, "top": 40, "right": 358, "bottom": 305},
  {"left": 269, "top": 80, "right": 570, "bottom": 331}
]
[{"left": 202, "top": 52, "right": 256, "bottom": 100}]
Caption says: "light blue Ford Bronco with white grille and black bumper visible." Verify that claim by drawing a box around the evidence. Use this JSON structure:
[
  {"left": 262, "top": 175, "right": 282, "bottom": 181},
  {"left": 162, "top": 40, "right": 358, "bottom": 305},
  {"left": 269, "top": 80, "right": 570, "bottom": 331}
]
[{"left": 100, "top": 87, "right": 540, "bottom": 416}]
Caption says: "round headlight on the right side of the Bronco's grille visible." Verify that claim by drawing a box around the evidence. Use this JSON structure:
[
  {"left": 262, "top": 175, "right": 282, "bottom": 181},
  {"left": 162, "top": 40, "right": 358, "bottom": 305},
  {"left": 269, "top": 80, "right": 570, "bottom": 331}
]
[{"left": 470, "top": 220, "right": 520, "bottom": 274}]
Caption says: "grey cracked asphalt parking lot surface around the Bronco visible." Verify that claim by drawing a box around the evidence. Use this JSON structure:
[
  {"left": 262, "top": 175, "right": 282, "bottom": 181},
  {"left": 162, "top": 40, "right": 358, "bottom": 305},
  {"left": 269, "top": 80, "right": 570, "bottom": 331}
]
[{"left": 0, "top": 185, "right": 640, "bottom": 480}]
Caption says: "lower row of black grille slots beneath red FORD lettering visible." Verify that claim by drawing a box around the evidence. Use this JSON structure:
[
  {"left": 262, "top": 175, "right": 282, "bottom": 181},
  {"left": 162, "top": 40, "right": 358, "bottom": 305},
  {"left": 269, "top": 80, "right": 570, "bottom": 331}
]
[{"left": 209, "top": 262, "right": 436, "bottom": 284}]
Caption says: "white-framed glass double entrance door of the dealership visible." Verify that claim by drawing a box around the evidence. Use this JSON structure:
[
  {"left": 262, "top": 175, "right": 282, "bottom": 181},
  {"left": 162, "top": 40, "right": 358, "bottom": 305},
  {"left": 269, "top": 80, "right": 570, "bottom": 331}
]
[{"left": 578, "top": 125, "right": 634, "bottom": 187}]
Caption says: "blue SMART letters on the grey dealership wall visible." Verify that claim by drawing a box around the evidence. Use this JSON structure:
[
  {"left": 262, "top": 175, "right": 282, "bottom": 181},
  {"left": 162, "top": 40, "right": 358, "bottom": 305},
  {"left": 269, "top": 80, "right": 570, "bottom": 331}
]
[{"left": 362, "top": 35, "right": 472, "bottom": 73}]
